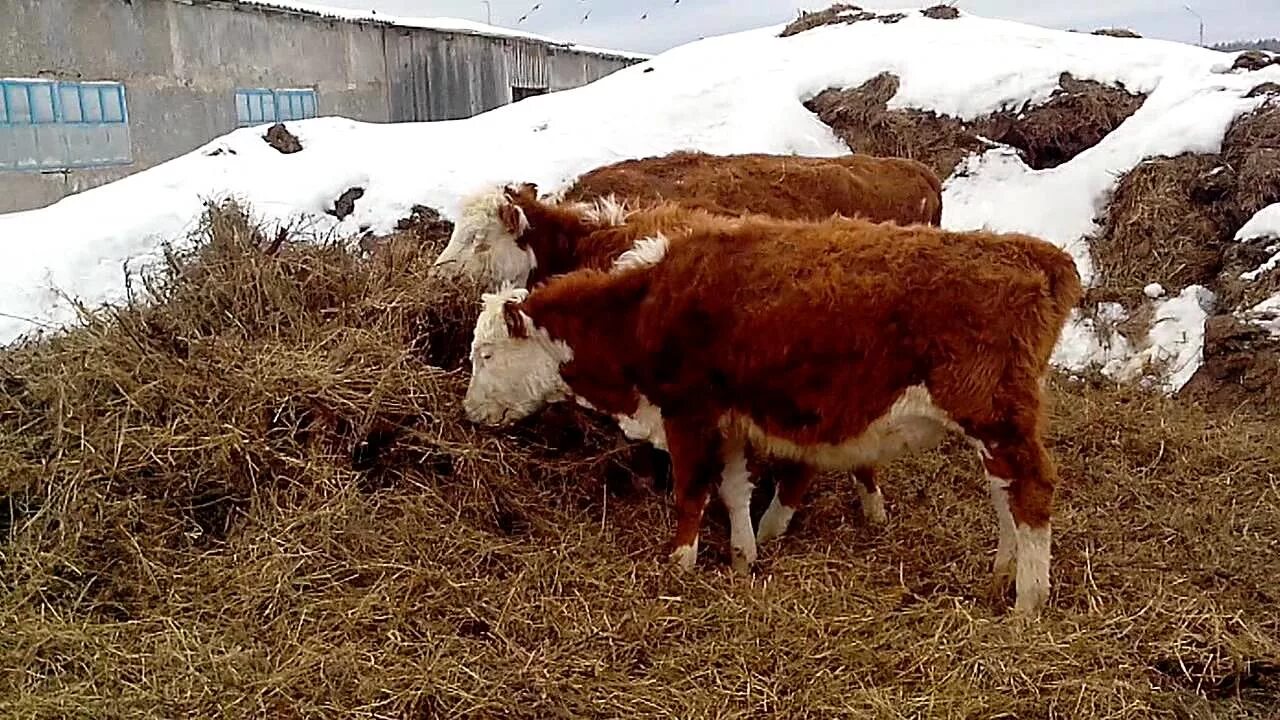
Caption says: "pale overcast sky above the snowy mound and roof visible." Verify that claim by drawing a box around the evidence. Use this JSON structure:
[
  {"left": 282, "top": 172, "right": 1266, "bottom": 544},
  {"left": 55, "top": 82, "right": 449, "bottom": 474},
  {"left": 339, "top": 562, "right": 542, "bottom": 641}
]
[{"left": 311, "top": 0, "right": 1280, "bottom": 53}]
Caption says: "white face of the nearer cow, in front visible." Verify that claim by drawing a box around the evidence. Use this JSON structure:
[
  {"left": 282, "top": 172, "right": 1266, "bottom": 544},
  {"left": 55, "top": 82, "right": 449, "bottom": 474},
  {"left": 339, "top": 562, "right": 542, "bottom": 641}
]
[{"left": 462, "top": 283, "right": 573, "bottom": 427}]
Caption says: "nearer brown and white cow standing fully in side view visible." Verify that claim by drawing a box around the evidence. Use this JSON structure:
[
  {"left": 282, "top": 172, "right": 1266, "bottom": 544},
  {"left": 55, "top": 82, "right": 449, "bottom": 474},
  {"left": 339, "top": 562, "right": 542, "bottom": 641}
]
[{"left": 463, "top": 204, "right": 1082, "bottom": 615}]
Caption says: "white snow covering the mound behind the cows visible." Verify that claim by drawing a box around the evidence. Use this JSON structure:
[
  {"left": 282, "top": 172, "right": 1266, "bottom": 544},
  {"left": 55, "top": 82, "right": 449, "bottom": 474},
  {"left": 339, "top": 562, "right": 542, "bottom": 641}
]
[{"left": 0, "top": 0, "right": 1264, "bottom": 387}]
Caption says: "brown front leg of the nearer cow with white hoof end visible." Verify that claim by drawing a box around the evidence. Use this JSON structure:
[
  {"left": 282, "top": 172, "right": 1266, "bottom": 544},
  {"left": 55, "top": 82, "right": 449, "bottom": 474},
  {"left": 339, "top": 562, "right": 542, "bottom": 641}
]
[{"left": 663, "top": 418, "right": 721, "bottom": 570}]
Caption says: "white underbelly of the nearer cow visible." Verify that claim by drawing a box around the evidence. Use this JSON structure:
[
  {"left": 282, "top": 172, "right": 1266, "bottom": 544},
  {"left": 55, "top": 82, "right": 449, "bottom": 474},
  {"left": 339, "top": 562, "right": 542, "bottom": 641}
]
[{"left": 721, "top": 386, "right": 960, "bottom": 470}]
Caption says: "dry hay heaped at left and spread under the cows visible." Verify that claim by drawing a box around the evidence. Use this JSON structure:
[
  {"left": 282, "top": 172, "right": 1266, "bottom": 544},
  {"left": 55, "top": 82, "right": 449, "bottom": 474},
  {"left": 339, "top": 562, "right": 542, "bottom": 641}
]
[{"left": 0, "top": 199, "right": 1280, "bottom": 719}]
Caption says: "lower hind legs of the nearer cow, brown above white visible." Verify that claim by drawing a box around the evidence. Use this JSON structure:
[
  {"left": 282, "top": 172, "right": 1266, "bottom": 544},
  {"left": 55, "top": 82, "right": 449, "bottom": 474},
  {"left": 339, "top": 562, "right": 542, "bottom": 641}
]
[{"left": 982, "top": 424, "right": 1056, "bottom": 616}]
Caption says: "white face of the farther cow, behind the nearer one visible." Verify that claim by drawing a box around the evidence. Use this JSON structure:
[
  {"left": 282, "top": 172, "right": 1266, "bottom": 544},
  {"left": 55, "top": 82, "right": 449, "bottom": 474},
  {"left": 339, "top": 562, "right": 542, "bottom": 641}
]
[{"left": 433, "top": 188, "right": 538, "bottom": 292}]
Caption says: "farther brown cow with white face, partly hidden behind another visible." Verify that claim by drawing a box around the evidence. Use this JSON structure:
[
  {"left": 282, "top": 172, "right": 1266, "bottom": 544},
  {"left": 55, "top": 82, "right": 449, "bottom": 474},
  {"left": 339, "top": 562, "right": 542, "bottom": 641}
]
[{"left": 434, "top": 152, "right": 942, "bottom": 291}]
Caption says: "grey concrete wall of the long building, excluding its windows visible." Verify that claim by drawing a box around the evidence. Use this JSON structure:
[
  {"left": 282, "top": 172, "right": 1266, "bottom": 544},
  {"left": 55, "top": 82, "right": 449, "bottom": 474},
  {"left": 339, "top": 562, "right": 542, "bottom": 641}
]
[{"left": 0, "top": 0, "right": 632, "bottom": 213}]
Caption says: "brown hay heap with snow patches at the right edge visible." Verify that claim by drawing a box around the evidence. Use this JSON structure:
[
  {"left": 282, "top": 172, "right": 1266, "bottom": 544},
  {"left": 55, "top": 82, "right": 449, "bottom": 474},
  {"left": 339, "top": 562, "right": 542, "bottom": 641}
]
[{"left": 1087, "top": 99, "right": 1280, "bottom": 415}]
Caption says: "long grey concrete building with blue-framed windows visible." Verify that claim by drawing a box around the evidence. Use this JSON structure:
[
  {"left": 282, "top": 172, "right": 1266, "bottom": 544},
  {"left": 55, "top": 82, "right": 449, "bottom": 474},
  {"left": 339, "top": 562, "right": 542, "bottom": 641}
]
[{"left": 0, "top": 0, "right": 644, "bottom": 213}]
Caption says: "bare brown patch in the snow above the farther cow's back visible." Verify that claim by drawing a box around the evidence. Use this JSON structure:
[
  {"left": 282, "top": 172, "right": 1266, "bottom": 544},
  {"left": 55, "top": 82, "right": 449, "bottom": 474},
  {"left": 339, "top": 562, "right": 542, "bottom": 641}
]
[{"left": 805, "top": 73, "right": 1146, "bottom": 178}]
